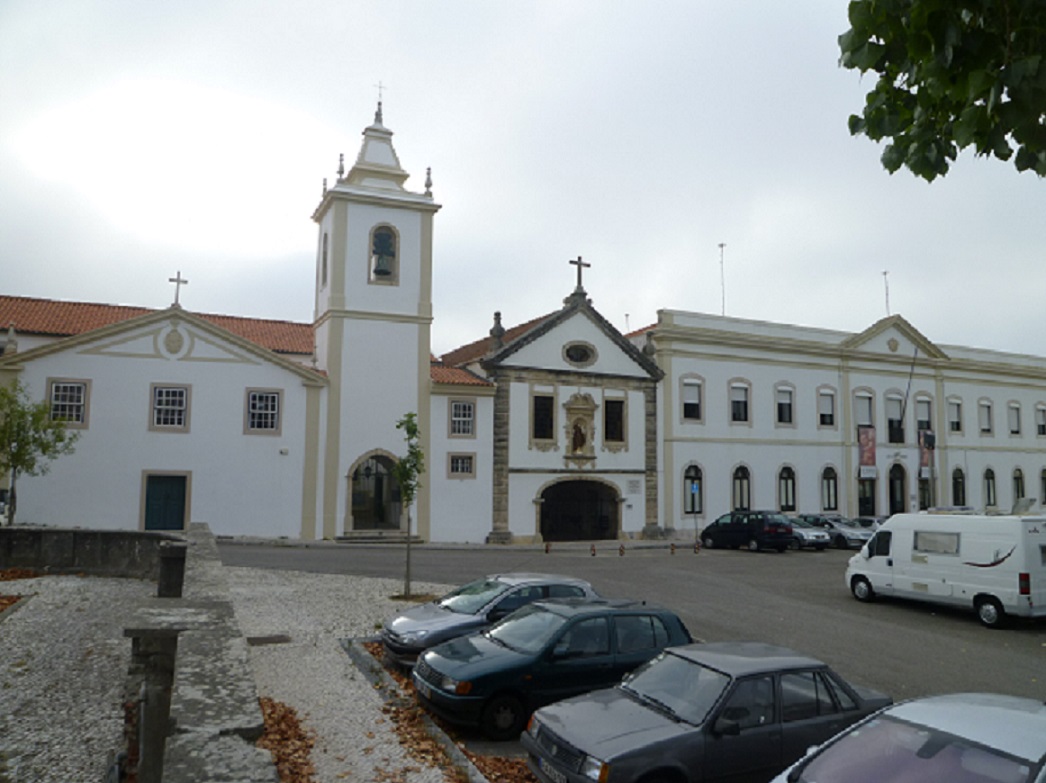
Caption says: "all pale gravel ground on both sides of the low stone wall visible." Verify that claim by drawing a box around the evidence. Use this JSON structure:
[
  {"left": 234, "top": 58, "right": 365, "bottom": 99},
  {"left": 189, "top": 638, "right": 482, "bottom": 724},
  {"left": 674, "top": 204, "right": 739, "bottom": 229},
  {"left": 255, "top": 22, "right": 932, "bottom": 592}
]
[{"left": 0, "top": 568, "right": 456, "bottom": 783}]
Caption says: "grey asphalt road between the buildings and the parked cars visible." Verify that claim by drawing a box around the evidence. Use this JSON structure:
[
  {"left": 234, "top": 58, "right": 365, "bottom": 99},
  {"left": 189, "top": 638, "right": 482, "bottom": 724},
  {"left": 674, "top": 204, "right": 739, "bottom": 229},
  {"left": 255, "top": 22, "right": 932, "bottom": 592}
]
[{"left": 219, "top": 542, "right": 1046, "bottom": 700}]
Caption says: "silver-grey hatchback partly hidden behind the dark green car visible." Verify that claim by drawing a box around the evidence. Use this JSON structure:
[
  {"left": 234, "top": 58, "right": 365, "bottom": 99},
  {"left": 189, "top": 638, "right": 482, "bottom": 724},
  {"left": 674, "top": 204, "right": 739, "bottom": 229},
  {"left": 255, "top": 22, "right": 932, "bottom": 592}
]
[{"left": 382, "top": 573, "right": 598, "bottom": 667}]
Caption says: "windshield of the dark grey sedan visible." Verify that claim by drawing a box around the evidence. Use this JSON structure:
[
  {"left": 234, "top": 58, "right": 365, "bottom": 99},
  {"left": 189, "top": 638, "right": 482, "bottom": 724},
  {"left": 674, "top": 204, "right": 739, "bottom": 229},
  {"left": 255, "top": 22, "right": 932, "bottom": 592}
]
[{"left": 621, "top": 652, "right": 730, "bottom": 726}]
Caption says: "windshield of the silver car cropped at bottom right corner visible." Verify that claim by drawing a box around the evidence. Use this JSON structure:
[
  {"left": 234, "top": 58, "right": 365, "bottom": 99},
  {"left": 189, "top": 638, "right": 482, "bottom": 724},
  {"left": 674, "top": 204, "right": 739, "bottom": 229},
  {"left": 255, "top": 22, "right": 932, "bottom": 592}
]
[{"left": 789, "top": 716, "right": 1037, "bottom": 783}]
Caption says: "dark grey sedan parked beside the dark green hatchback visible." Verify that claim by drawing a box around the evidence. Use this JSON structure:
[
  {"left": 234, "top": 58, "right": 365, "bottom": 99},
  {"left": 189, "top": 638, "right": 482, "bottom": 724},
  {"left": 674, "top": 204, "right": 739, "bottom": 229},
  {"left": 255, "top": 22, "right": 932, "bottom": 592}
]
[{"left": 521, "top": 642, "right": 890, "bottom": 783}]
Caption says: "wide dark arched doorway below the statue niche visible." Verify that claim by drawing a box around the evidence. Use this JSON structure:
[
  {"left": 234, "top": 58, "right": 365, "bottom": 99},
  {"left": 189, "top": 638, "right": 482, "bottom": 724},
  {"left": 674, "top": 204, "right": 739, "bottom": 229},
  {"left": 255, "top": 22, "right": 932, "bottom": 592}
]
[{"left": 541, "top": 481, "right": 619, "bottom": 542}]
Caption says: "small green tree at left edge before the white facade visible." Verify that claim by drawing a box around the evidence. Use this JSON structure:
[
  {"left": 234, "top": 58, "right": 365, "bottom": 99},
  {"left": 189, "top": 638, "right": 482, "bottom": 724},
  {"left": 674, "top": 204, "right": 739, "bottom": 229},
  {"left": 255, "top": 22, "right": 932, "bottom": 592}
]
[{"left": 0, "top": 381, "right": 79, "bottom": 525}]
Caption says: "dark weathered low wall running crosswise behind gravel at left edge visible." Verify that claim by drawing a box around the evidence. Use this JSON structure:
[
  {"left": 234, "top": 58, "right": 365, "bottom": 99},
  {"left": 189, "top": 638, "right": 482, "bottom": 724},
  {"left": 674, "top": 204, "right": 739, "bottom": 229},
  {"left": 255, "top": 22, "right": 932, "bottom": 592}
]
[{"left": 0, "top": 526, "right": 183, "bottom": 579}]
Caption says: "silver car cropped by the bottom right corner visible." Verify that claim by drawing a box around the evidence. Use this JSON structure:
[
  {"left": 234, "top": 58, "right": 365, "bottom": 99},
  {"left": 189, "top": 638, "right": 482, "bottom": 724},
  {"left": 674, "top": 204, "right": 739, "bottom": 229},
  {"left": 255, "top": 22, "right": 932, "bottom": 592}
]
[{"left": 772, "top": 693, "right": 1046, "bottom": 783}]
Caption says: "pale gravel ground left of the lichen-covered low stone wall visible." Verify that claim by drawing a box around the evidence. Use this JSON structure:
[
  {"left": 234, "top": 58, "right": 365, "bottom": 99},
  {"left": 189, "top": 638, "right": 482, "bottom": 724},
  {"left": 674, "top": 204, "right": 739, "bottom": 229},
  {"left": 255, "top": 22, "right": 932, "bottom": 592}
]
[{"left": 0, "top": 576, "right": 156, "bottom": 783}]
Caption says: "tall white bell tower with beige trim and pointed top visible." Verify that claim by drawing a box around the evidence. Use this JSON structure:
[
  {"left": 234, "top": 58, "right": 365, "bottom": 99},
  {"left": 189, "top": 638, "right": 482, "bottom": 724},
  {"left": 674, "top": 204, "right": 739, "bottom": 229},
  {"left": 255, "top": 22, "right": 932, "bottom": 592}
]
[{"left": 313, "top": 107, "right": 439, "bottom": 538}]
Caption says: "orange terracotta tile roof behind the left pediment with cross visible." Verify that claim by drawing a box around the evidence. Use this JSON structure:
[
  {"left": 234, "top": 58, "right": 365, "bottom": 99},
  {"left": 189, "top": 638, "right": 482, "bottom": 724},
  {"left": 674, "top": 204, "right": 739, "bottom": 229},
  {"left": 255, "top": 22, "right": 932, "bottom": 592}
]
[{"left": 0, "top": 295, "right": 313, "bottom": 355}]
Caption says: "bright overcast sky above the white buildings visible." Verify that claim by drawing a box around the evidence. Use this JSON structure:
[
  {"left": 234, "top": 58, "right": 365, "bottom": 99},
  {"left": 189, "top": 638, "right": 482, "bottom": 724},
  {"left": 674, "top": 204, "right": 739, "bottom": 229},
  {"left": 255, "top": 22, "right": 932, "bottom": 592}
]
[{"left": 0, "top": 0, "right": 1046, "bottom": 354}]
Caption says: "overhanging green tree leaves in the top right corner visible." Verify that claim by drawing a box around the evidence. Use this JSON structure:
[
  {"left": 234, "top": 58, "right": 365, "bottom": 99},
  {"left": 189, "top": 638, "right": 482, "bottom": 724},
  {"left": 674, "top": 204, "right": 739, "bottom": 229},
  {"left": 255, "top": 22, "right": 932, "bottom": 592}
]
[{"left": 839, "top": 0, "right": 1046, "bottom": 182}]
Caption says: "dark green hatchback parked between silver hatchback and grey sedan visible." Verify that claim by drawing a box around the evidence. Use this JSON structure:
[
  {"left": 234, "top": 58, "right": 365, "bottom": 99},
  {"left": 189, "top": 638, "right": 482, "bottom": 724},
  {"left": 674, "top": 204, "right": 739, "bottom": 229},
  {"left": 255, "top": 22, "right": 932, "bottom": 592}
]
[{"left": 413, "top": 599, "right": 691, "bottom": 739}]
